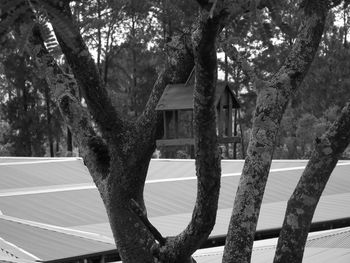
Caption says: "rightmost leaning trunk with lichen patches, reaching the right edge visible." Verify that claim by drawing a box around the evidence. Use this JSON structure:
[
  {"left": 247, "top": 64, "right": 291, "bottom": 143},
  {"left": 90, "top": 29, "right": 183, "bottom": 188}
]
[{"left": 274, "top": 103, "right": 350, "bottom": 263}]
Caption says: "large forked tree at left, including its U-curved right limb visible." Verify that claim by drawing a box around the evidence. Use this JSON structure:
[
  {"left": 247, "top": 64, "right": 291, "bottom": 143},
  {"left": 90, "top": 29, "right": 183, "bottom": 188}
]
[{"left": 30, "top": 1, "right": 231, "bottom": 262}]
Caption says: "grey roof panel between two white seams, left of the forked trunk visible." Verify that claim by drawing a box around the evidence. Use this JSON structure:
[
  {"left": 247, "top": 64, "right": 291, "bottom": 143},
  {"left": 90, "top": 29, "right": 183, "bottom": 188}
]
[{"left": 0, "top": 189, "right": 108, "bottom": 226}]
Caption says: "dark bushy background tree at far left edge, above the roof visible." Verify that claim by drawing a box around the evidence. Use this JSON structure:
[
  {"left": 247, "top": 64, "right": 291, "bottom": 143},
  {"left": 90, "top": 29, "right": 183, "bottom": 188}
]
[{"left": 2, "top": 33, "right": 56, "bottom": 156}]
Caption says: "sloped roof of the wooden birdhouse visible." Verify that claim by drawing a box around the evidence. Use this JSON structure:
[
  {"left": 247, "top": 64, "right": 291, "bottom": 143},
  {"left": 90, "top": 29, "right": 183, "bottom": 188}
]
[{"left": 156, "top": 82, "right": 239, "bottom": 110}]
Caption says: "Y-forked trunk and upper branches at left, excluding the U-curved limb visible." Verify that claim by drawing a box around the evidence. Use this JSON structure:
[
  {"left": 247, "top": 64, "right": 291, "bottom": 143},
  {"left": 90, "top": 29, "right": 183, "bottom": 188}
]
[{"left": 32, "top": 4, "right": 193, "bottom": 263}]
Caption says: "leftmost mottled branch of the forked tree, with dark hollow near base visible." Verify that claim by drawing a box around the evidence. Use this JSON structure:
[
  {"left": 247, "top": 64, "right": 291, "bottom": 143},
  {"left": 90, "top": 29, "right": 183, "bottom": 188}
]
[{"left": 30, "top": 27, "right": 110, "bottom": 194}]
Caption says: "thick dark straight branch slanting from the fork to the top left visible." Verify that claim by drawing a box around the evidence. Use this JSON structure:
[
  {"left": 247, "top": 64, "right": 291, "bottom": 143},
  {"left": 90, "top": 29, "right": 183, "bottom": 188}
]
[{"left": 41, "top": 1, "right": 125, "bottom": 141}]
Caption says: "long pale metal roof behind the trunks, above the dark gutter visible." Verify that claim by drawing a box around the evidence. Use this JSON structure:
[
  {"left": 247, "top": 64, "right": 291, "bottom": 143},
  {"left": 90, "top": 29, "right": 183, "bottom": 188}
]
[{"left": 0, "top": 159, "right": 350, "bottom": 260}]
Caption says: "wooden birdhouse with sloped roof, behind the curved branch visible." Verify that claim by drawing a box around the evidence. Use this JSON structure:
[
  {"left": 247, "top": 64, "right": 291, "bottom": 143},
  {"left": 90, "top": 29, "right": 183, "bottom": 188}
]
[{"left": 156, "top": 73, "right": 241, "bottom": 158}]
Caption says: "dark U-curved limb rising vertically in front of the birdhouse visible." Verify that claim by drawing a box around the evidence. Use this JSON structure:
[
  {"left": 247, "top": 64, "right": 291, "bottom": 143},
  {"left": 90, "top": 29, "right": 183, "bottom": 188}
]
[{"left": 155, "top": 12, "right": 221, "bottom": 262}]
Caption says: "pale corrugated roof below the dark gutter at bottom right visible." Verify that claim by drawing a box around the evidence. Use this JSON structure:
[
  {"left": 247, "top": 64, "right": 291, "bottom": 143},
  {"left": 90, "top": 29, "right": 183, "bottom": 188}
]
[{"left": 194, "top": 227, "right": 350, "bottom": 263}]
